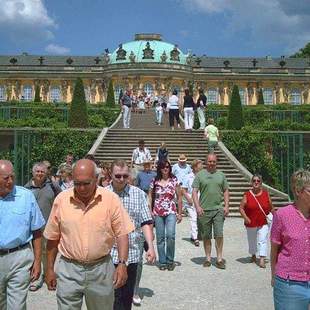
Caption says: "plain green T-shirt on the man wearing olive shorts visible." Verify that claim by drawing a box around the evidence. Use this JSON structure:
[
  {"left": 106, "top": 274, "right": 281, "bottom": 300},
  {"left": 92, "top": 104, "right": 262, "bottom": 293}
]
[{"left": 192, "top": 169, "right": 228, "bottom": 211}]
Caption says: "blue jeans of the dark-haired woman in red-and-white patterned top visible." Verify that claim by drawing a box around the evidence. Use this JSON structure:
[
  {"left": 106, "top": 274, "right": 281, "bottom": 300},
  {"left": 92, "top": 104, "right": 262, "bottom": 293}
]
[{"left": 155, "top": 214, "right": 177, "bottom": 265}]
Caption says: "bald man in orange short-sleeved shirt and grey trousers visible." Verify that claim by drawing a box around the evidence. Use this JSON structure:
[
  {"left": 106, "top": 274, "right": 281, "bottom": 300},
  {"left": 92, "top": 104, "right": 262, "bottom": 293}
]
[{"left": 44, "top": 159, "right": 134, "bottom": 310}]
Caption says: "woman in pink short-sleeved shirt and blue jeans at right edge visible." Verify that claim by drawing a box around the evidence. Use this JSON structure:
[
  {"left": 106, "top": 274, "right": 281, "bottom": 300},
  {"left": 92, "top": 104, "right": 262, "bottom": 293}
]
[{"left": 270, "top": 170, "right": 310, "bottom": 310}]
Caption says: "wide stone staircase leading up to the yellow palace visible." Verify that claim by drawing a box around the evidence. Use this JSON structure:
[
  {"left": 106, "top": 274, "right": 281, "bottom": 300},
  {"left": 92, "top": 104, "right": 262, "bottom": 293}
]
[{"left": 91, "top": 111, "right": 289, "bottom": 216}]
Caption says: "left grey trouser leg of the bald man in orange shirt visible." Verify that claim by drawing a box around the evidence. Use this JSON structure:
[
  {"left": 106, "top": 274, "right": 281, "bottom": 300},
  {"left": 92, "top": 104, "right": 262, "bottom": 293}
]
[{"left": 56, "top": 257, "right": 86, "bottom": 310}]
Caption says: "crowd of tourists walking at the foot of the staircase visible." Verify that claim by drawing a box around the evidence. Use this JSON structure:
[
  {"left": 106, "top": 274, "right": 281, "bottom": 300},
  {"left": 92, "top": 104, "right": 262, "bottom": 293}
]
[{"left": 0, "top": 139, "right": 310, "bottom": 310}]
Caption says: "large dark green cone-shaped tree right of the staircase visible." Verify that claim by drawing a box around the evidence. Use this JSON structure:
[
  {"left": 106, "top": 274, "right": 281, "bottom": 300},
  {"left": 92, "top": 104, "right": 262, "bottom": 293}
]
[{"left": 227, "top": 85, "right": 244, "bottom": 130}]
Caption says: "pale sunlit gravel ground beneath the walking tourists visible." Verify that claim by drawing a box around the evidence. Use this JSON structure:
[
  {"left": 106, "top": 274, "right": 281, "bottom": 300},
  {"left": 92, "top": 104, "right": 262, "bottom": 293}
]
[{"left": 28, "top": 218, "right": 273, "bottom": 310}]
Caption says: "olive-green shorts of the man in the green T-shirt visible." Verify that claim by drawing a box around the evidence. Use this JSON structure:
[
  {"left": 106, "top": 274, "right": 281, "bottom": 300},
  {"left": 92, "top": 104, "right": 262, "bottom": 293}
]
[{"left": 197, "top": 209, "right": 225, "bottom": 240}]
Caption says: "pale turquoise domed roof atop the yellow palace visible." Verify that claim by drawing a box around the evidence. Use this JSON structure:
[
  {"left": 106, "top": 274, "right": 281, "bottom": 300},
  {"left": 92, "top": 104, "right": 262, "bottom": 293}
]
[{"left": 110, "top": 34, "right": 187, "bottom": 65}]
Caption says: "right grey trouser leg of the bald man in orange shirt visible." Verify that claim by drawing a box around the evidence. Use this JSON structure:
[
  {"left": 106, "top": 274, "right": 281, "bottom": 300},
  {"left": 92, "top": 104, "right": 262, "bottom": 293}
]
[{"left": 84, "top": 256, "right": 114, "bottom": 310}]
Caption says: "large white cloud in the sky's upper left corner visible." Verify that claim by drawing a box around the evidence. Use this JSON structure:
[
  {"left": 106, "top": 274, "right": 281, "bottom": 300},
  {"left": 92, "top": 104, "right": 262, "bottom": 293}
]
[{"left": 0, "top": 0, "right": 57, "bottom": 42}]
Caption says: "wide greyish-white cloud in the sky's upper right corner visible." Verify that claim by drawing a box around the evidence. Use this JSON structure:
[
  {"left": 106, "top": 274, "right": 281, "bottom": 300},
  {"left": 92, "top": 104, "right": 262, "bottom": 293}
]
[{"left": 177, "top": 0, "right": 310, "bottom": 54}]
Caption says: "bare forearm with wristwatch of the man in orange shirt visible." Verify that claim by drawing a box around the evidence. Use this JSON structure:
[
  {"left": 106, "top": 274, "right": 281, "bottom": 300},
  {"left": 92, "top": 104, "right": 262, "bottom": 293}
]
[{"left": 113, "top": 235, "right": 129, "bottom": 288}]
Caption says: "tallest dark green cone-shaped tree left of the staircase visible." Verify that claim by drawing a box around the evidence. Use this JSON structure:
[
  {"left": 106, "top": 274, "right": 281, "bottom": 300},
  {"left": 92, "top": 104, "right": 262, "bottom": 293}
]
[{"left": 68, "top": 78, "right": 88, "bottom": 128}]
